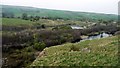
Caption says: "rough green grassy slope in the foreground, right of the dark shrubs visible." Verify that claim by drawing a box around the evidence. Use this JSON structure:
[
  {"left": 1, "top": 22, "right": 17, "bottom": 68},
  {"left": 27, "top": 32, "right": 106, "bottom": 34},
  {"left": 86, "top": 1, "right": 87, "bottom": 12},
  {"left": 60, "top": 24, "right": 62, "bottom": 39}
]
[{"left": 32, "top": 36, "right": 118, "bottom": 66}]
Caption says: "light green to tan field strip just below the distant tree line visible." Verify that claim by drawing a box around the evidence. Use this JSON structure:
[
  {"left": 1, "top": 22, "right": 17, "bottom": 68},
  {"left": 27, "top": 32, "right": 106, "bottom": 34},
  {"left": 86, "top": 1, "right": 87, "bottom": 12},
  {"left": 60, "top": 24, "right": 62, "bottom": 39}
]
[{"left": 0, "top": 18, "right": 92, "bottom": 26}]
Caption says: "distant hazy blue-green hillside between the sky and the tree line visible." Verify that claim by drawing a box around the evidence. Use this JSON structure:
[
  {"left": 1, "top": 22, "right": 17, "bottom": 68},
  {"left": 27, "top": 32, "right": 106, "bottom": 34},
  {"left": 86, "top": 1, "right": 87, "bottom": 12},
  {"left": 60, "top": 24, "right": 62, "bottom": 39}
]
[{"left": 2, "top": 5, "right": 117, "bottom": 21}]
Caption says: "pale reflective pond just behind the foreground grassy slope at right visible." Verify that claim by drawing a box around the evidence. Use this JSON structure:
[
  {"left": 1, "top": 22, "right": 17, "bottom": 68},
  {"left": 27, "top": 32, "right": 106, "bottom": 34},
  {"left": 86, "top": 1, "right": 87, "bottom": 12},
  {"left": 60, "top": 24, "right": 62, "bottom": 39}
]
[{"left": 81, "top": 32, "right": 112, "bottom": 41}]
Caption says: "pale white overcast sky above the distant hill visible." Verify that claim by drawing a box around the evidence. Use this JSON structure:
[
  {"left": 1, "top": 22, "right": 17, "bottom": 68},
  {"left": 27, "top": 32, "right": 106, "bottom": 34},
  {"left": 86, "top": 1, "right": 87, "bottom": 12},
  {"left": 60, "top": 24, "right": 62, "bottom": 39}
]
[{"left": 0, "top": 0, "right": 120, "bottom": 14}]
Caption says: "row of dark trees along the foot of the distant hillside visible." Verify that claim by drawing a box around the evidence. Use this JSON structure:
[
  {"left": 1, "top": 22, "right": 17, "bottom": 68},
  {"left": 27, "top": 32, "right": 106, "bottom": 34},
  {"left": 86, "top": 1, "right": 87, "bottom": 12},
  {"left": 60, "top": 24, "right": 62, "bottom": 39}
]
[{"left": 2, "top": 12, "right": 114, "bottom": 24}]
